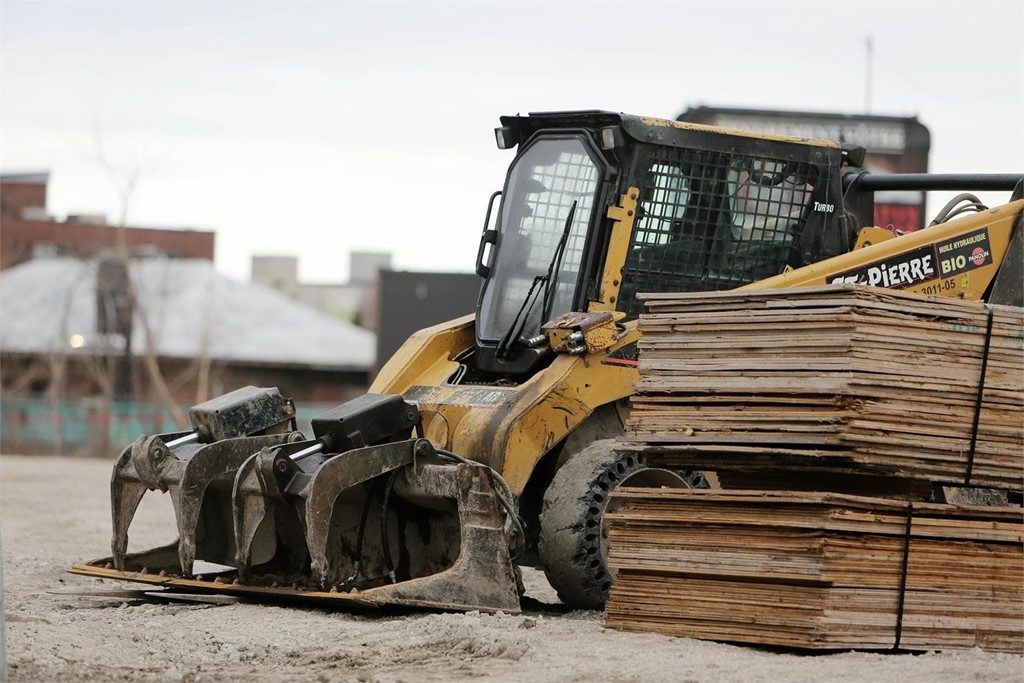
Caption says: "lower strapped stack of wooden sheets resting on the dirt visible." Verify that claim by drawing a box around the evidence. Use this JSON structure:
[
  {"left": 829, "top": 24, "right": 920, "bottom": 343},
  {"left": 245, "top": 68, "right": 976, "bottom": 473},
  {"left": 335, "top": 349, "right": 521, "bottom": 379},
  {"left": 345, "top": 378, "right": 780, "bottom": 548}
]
[{"left": 605, "top": 488, "right": 1024, "bottom": 652}]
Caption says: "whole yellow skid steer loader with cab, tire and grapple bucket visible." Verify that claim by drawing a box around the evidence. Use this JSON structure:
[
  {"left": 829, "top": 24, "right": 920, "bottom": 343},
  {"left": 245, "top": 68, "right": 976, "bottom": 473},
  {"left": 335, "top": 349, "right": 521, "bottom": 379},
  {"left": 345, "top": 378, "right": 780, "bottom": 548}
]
[{"left": 73, "top": 112, "right": 1024, "bottom": 611}]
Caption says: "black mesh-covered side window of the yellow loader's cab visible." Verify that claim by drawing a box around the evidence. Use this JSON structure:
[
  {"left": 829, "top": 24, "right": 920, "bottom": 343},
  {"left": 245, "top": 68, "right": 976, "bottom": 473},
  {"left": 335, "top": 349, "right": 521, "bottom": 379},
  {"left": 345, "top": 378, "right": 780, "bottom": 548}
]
[{"left": 618, "top": 147, "right": 816, "bottom": 317}]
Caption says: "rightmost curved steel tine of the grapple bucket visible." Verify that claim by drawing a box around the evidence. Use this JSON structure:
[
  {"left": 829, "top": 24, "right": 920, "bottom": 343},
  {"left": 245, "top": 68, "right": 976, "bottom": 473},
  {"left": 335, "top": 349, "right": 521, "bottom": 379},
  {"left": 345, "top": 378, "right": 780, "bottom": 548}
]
[{"left": 298, "top": 439, "right": 421, "bottom": 587}]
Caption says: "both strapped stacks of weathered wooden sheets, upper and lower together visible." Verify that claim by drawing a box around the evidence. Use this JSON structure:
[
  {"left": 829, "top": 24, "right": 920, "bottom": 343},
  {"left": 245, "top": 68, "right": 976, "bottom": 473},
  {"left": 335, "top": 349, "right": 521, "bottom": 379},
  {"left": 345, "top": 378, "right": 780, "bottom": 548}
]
[{"left": 605, "top": 286, "right": 1024, "bottom": 652}]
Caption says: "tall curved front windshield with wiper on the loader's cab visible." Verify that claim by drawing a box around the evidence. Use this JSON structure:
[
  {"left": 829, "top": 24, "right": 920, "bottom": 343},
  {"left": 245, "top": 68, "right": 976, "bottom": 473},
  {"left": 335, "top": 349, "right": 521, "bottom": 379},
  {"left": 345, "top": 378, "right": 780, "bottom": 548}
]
[{"left": 477, "top": 137, "right": 601, "bottom": 341}]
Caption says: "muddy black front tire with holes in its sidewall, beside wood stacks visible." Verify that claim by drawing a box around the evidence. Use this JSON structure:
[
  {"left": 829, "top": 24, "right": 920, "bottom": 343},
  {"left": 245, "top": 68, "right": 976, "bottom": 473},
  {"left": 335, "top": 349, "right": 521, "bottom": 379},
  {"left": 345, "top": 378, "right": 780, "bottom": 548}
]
[{"left": 538, "top": 439, "right": 675, "bottom": 609}]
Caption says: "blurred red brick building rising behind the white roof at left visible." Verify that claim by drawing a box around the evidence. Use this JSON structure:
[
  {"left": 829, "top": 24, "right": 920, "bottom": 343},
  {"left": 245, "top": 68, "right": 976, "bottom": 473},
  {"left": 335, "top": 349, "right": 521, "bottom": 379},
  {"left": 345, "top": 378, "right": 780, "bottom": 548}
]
[{"left": 0, "top": 173, "right": 214, "bottom": 270}]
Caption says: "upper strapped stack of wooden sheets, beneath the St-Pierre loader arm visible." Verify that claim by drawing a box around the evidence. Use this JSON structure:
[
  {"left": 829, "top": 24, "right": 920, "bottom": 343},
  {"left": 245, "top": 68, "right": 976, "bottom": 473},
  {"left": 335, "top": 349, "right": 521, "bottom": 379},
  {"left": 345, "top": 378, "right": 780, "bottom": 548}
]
[{"left": 626, "top": 286, "right": 1024, "bottom": 489}]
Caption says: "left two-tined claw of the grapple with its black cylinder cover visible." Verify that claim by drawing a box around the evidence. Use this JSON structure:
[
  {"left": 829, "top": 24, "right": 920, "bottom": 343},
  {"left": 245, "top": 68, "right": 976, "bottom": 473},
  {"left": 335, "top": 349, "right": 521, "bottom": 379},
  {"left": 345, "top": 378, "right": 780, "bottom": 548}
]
[{"left": 111, "top": 386, "right": 302, "bottom": 575}]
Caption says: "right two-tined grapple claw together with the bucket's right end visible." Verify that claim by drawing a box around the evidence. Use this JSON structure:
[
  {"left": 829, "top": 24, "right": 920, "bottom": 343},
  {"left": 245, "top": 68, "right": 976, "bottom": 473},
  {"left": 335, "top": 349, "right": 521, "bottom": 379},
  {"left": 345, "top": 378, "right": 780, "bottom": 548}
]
[{"left": 233, "top": 394, "right": 519, "bottom": 611}]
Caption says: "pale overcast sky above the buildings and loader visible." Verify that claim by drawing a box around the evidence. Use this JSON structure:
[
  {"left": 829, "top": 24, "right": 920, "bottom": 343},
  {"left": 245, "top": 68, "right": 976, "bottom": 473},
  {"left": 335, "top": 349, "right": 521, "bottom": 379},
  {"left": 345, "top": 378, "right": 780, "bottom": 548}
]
[{"left": 0, "top": 0, "right": 1024, "bottom": 283}]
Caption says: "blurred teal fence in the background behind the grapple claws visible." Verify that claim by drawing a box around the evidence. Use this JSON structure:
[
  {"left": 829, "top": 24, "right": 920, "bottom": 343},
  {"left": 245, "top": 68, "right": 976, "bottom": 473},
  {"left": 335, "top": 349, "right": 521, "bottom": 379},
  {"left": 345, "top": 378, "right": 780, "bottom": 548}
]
[{"left": 0, "top": 398, "right": 332, "bottom": 457}]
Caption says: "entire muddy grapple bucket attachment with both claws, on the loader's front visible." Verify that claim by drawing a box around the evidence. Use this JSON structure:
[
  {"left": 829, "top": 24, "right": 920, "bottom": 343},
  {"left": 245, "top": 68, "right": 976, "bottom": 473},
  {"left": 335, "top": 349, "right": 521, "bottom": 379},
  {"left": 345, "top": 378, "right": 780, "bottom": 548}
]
[{"left": 81, "top": 387, "right": 522, "bottom": 612}]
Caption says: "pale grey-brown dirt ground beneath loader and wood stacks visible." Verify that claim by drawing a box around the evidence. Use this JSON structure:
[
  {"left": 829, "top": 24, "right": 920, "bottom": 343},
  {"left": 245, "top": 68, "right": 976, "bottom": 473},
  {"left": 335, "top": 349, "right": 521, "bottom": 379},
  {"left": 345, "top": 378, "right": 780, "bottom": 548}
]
[{"left": 0, "top": 456, "right": 1024, "bottom": 683}]
